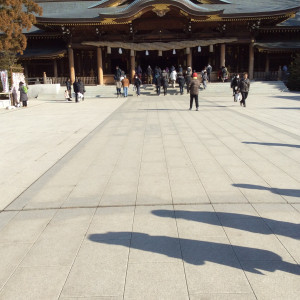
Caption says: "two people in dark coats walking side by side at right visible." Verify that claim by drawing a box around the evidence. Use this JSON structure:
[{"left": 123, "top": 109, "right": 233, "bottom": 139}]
[{"left": 230, "top": 73, "right": 250, "bottom": 107}]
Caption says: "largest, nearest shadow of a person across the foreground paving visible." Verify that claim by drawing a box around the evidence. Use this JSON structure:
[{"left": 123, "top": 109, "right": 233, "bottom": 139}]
[{"left": 88, "top": 232, "right": 300, "bottom": 275}]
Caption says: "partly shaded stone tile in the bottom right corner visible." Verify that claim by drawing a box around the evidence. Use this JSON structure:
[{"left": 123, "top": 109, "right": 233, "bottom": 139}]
[{"left": 241, "top": 261, "right": 300, "bottom": 300}]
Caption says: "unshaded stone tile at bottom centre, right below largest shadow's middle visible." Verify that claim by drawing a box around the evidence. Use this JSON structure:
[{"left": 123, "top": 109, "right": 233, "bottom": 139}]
[{"left": 124, "top": 262, "right": 189, "bottom": 300}]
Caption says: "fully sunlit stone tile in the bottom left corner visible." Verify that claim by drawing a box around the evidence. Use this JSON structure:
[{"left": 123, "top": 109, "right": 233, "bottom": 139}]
[{"left": 0, "top": 267, "right": 70, "bottom": 299}]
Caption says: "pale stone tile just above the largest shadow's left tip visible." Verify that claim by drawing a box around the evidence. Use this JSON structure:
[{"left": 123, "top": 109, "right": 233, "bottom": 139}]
[{"left": 88, "top": 207, "right": 134, "bottom": 239}]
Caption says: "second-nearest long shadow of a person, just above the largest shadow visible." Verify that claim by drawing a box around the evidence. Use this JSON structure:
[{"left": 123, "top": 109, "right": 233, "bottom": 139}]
[{"left": 152, "top": 210, "right": 300, "bottom": 240}]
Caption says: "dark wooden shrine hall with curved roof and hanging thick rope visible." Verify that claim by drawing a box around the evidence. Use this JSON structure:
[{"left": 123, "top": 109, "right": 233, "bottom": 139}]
[{"left": 20, "top": 0, "right": 300, "bottom": 84}]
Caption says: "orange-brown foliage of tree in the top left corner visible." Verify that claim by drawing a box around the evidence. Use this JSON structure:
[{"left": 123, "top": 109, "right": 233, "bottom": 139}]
[{"left": 0, "top": 0, "right": 42, "bottom": 54}]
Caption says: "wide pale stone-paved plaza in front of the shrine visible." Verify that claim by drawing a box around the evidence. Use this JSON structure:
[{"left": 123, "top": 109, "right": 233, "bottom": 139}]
[{"left": 0, "top": 84, "right": 300, "bottom": 300}]
